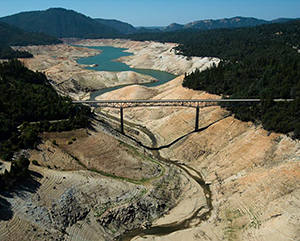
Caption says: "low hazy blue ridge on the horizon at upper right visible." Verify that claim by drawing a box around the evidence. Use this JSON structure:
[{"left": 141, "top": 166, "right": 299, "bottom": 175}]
[{"left": 163, "top": 17, "right": 292, "bottom": 32}]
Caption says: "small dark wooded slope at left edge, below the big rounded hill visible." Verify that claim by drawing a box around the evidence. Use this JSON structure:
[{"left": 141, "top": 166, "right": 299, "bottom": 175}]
[{"left": 0, "top": 21, "right": 61, "bottom": 59}]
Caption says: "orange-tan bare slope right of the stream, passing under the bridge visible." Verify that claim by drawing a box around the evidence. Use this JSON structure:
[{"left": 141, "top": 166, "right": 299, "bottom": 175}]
[{"left": 98, "top": 74, "right": 300, "bottom": 241}]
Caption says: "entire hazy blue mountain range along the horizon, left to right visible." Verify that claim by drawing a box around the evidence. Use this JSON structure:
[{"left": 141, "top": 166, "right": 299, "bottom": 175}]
[{"left": 0, "top": 8, "right": 298, "bottom": 38}]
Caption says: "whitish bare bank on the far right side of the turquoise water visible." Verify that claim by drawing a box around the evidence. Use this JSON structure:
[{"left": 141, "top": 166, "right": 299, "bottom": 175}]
[{"left": 76, "top": 39, "right": 220, "bottom": 75}]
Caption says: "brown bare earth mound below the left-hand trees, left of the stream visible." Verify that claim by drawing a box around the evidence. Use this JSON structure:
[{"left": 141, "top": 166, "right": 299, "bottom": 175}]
[{"left": 31, "top": 124, "right": 161, "bottom": 180}]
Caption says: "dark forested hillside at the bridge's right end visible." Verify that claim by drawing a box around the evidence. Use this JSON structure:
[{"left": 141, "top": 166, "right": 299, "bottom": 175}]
[{"left": 130, "top": 20, "right": 300, "bottom": 138}]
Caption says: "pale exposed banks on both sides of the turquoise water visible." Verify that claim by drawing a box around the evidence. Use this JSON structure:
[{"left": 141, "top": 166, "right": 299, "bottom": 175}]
[{"left": 18, "top": 39, "right": 219, "bottom": 100}]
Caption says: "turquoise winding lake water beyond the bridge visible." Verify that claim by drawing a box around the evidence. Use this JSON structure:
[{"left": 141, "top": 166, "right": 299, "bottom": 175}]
[{"left": 76, "top": 45, "right": 177, "bottom": 100}]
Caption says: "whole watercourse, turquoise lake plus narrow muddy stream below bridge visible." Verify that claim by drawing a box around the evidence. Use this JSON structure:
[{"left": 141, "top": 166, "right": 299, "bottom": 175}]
[{"left": 77, "top": 46, "right": 213, "bottom": 241}]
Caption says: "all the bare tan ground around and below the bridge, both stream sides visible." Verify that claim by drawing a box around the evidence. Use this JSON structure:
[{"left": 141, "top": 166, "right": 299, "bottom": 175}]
[{"left": 0, "top": 40, "right": 300, "bottom": 241}]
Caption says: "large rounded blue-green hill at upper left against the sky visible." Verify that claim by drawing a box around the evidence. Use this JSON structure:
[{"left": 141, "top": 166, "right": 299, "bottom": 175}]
[{"left": 0, "top": 8, "right": 121, "bottom": 38}]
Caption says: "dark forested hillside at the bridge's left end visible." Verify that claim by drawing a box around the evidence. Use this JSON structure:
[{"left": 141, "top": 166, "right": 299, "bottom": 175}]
[{"left": 0, "top": 60, "right": 90, "bottom": 160}]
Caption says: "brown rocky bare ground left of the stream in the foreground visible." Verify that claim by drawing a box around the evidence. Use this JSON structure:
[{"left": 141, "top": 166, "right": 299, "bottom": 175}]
[{"left": 0, "top": 116, "right": 206, "bottom": 240}]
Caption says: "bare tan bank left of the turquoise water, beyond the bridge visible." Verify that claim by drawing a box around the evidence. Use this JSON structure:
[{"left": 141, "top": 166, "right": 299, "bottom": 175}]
[{"left": 19, "top": 44, "right": 157, "bottom": 99}]
